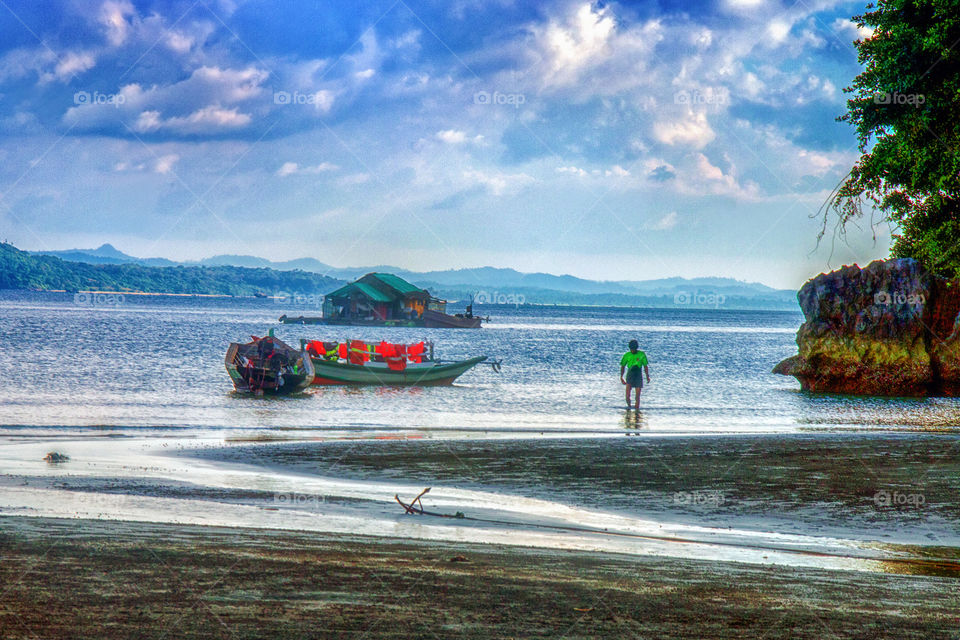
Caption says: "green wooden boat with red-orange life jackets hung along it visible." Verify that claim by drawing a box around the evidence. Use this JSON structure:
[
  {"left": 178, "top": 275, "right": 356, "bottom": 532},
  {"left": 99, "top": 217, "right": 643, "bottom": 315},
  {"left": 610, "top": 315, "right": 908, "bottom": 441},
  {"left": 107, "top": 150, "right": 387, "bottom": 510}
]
[{"left": 305, "top": 340, "right": 500, "bottom": 387}]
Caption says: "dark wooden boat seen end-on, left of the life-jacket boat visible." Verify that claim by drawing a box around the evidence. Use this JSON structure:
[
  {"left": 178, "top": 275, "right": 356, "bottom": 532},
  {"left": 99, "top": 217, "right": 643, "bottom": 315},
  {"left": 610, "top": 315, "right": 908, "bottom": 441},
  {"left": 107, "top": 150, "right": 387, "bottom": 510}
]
[{"left": 224, "top": 330, "right": 314, "bottom": 395}]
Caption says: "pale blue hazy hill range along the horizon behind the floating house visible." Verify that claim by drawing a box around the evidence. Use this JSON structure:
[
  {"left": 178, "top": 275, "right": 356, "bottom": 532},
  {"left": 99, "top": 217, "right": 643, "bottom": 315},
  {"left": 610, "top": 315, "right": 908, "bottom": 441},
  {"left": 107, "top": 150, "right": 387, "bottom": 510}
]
[{"left": 26, "top": 244, "right": 797, "bottom": 309}]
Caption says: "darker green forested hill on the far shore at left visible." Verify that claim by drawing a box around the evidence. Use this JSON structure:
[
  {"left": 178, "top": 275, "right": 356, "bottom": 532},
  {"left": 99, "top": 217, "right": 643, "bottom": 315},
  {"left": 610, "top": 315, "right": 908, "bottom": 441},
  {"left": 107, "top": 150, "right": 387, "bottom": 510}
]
[{"left": 0, "top": 243, "right": 343, "bottom": 296}]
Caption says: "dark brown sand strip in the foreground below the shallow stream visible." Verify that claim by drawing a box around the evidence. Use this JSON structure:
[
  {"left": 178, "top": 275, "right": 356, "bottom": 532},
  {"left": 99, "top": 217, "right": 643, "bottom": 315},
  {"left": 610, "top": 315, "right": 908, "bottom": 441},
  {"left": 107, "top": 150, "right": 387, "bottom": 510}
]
[{"left": 0, "top": 517, "right": 960, "bottom": 640}]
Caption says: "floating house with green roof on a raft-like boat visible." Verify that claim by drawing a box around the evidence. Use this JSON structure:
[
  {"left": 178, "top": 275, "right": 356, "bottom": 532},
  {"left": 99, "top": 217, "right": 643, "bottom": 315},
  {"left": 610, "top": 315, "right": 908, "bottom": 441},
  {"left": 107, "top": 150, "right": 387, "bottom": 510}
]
[{"left": 280, "top": 273, "right": 481, "bottom": 329}]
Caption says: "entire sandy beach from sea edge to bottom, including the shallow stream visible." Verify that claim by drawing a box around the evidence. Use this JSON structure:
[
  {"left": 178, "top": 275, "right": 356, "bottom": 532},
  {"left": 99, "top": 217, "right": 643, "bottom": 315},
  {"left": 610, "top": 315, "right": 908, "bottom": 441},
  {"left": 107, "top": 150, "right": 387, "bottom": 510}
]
[{"left": 0, "top": 432, "right": 960, "bottom": 638}]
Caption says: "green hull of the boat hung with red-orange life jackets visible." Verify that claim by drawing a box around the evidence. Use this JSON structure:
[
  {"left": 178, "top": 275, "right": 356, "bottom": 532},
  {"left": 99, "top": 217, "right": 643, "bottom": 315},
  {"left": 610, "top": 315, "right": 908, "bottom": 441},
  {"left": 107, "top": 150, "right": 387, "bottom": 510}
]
[{"left": 313, "top": 356, "right": 487, "bottom": 387}]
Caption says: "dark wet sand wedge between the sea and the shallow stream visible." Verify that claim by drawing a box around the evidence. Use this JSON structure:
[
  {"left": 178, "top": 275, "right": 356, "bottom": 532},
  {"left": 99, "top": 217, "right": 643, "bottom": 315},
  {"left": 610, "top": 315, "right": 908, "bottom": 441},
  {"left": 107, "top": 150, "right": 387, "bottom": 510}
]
[{"left": 190, "top": 431, "right": 960, "bottom": 547}]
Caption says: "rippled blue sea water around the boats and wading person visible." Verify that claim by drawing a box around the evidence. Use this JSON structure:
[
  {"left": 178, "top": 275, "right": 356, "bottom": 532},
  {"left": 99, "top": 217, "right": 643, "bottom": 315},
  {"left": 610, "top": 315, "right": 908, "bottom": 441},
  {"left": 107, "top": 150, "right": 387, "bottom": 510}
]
[{"left": 0, "top": 291, "right": 960, "bottom": 432}]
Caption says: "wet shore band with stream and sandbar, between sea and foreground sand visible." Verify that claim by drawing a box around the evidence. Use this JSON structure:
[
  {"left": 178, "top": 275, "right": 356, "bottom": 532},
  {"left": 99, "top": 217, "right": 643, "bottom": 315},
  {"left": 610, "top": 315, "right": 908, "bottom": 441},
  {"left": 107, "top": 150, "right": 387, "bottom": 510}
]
[{"left": 0, "top": 435, "right": 960, "bottom": 577}]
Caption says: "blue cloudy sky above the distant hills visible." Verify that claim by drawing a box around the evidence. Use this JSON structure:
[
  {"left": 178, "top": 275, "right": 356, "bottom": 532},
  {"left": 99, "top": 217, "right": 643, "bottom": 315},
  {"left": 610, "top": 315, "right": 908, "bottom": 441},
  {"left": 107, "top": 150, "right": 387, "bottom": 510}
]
[{"left": 0, "top": 0, "right": 890, "bottom": 288}]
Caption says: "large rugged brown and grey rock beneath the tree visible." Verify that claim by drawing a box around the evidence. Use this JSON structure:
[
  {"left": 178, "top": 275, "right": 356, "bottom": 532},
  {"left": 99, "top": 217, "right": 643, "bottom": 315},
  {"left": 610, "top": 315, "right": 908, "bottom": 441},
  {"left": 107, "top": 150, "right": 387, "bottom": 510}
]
[{"left": 773, "top": 259, "right": 960, "bottom": 396}]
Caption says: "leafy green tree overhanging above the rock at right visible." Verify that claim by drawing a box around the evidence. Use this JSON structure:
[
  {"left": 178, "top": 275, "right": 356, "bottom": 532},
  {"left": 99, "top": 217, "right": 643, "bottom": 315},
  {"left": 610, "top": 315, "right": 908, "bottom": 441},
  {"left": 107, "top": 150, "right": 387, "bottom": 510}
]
[{"left": 824, "top": 0, "right": 960, "bottom": 277}]
